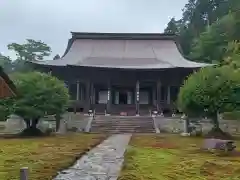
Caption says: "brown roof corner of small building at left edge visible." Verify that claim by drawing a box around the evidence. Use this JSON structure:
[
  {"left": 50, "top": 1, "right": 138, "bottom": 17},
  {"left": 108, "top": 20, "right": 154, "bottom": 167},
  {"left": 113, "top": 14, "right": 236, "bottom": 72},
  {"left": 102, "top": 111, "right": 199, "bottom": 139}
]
[{"left": 0, "top": 67, "right": 16, "bottom": 99}]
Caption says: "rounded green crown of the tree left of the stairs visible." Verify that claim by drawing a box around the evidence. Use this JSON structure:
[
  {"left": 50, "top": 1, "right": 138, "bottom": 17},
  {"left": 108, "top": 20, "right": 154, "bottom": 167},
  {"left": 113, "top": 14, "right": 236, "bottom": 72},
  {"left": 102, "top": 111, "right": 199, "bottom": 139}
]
[{"left": 1, "top": 72, "right": 69, "bottom": 119}]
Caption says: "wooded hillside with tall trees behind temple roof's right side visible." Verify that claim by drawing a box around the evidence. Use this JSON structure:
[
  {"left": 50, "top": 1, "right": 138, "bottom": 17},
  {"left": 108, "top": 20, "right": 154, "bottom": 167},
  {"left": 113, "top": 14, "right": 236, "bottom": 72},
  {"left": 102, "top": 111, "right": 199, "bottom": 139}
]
[{"left": 165, "top": 0, "right": 240, "bottom": 63}]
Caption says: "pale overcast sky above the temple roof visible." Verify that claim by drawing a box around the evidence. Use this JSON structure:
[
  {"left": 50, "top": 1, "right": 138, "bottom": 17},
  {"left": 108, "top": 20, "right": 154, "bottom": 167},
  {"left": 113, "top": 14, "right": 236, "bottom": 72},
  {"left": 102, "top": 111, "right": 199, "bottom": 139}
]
[{"left": 0, "top": 0, "right": 187, "bottom": 57}]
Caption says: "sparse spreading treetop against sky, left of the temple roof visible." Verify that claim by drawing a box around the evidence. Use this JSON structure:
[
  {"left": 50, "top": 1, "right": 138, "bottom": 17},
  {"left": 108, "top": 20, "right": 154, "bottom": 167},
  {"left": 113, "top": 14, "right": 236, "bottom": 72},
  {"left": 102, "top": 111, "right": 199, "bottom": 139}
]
[{"left": 8, "top": 39, "right": 51, "bottom": 61}]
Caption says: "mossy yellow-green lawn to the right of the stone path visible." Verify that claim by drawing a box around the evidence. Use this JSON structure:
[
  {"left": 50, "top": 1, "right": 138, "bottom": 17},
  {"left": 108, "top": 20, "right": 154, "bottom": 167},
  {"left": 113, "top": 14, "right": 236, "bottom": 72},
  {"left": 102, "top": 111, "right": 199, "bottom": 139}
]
[{"left": 118, "top": 135, "right": 240, "bottom": 180}]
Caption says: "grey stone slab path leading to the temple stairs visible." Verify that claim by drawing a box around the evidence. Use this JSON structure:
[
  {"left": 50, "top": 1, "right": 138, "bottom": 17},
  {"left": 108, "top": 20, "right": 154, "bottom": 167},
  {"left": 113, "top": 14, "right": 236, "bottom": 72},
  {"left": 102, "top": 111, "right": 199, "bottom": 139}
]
[{"left": 54, "top": 134, "right": 131, "bottom": 180}]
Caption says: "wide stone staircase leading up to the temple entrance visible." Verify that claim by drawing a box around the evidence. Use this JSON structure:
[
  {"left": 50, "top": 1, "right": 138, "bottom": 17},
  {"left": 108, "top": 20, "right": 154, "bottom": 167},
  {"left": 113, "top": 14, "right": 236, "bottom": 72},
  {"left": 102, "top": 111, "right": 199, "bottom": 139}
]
[{"left": 91, "top": 116, "right": 155, "bottom": 134}]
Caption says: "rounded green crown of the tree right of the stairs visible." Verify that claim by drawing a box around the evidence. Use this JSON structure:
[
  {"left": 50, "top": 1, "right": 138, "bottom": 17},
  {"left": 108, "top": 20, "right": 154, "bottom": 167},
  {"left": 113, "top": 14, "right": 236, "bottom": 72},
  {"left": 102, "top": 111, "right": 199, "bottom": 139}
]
[{"left": 178, "top": 66, "right": 240, "bottom": 116}]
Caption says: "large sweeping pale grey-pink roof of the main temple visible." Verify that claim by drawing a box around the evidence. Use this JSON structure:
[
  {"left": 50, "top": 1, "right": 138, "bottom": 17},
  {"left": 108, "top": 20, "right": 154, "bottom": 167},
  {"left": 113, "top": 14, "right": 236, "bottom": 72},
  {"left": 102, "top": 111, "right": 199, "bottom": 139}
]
[{"left": 33, "top": 32, "right": 209, "bottom": 69}]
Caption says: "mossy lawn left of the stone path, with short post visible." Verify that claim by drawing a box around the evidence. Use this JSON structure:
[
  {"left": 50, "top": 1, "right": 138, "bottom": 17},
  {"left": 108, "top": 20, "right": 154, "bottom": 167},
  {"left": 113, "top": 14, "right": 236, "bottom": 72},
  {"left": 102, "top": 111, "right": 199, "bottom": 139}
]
[{"left": 0, "top": 133, "right": 105, "bottom": 180}]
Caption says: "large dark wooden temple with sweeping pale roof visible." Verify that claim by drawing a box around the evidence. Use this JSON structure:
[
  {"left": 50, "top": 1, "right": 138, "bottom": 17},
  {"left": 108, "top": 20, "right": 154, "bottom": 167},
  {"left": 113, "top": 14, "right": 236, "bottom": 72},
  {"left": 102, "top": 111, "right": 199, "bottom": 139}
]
[{"left": 32, "top": 32, "right": 207, "bottom": 115}]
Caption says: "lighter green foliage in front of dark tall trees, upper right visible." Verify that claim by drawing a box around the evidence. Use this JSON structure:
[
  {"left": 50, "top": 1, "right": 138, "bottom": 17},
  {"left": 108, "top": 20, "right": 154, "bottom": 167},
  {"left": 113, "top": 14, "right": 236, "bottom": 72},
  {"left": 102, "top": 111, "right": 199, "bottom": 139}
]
[{"left": 190, "top": 14, "right": 236, "bottom": 63}]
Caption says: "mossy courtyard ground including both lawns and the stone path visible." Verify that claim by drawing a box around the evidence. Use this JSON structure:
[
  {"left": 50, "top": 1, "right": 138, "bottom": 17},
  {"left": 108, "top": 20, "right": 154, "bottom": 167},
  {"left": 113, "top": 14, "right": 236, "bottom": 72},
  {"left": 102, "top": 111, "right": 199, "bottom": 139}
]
[{"left": 0, "top": 133, "right": 240, "bottom": 180}]
